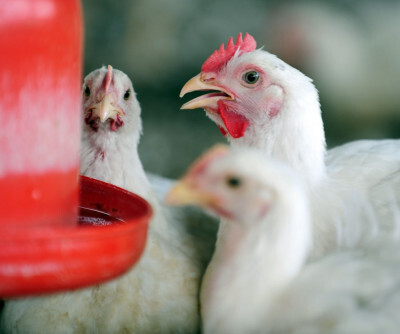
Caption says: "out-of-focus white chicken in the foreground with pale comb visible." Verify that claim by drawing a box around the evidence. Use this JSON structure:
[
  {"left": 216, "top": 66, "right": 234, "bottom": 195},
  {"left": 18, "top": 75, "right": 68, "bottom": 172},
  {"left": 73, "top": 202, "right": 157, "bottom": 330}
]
[{"left": 168, "top": 147, "right": 400, "bottom": 334}]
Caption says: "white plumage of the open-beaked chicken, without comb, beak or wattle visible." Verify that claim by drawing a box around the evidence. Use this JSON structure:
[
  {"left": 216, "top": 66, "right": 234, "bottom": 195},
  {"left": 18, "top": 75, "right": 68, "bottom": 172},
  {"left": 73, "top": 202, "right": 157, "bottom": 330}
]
[{"left": 206, "top": 49, "right": 400, "bottom": 256}]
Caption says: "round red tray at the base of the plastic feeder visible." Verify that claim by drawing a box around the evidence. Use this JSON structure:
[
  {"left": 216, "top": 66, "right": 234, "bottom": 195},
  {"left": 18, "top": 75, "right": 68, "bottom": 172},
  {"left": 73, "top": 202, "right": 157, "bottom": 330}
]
[{"left": 0, "top": 176, "right": 152, "bottom": 297}]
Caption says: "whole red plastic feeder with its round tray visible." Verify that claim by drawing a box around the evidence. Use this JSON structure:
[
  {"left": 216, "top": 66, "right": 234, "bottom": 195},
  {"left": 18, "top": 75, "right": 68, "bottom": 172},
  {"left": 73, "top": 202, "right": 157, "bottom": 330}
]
[{"left": 0, "top": 0, "right": 151, "bottom": 297}]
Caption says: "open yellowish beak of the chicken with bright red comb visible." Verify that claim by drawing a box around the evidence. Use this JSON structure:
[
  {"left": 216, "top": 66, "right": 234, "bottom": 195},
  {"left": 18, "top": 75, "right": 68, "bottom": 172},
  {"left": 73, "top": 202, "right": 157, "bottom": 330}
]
[{"left": 179, "top": 73, "right": 235, "bottom": 109}]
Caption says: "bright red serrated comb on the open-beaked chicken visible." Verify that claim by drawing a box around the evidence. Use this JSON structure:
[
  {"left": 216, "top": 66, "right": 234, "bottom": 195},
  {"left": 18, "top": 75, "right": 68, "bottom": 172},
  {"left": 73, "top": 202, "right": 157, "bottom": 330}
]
[{"left": 201, "top": 33, "right": 257, "bottom": 72}]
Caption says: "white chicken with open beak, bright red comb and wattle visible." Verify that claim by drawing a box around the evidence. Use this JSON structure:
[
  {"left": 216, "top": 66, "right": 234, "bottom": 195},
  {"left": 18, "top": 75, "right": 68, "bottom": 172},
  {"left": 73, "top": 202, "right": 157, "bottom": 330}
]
[{"left": 181, "top": 34, "right": 400, "bottom": 255}]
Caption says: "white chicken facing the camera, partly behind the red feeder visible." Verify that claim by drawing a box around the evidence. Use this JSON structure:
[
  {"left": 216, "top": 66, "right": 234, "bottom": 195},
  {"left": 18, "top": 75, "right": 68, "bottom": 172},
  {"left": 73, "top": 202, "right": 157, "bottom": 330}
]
[{"left": 1, "top": 66, "right": 215, "bottom": 334}]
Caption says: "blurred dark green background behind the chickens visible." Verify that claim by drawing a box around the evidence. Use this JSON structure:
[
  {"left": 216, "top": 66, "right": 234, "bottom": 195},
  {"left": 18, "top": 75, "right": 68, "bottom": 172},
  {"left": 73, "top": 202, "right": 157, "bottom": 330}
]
[{"left": 82, "top": 0, "right": 400, "bottom": 178}]
